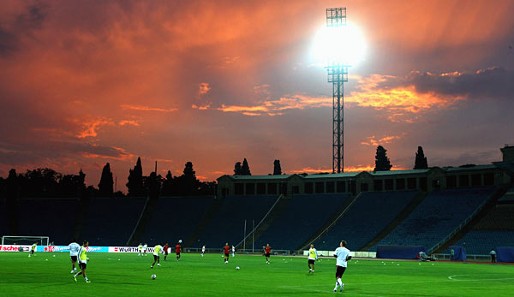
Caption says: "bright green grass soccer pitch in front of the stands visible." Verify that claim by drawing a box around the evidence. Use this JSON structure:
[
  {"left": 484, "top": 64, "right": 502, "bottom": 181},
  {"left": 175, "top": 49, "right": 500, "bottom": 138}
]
[{"left": 0, "top": 253, "right": 514, "bottom": 297}]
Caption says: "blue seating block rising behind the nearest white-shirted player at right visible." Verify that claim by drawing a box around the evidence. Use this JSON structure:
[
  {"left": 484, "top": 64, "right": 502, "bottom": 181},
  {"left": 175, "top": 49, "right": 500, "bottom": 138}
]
[{"left": 315, "top": 191, "right": 418, "bottom": 250}]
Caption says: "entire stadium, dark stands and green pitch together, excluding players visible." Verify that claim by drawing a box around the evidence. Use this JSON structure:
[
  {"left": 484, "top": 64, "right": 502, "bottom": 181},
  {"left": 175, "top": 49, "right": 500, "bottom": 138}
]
[{"left": 0, "top": 146, "right": 514, "bottom": 296}]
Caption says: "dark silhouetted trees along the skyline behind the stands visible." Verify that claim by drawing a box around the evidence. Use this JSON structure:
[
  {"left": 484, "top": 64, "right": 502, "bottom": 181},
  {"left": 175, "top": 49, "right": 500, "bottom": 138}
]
[{"left": 0, "top": 145, "right": 428, "bottom": 199}]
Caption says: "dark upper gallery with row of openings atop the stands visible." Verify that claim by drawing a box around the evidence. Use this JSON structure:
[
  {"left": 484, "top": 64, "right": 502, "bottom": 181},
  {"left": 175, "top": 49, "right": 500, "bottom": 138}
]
[{"left": 217, "top": 146, "right": 514, "bottom": 197}]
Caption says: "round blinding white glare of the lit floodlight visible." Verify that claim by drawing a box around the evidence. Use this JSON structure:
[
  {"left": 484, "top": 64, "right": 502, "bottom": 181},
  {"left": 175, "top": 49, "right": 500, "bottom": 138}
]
[{"left": 312, "top": 22, "right": 367, "bottom": 66}]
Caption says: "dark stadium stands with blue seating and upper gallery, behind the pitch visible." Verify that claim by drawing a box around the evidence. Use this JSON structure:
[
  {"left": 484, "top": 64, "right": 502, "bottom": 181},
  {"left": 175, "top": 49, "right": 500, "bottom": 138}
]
[{"left": 0, "top": 146, "right": 514, "bottom": 256}]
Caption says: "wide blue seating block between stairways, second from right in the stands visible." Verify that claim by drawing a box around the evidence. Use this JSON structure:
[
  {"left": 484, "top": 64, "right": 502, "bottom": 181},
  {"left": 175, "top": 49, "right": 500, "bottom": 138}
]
[{"left": 371, "top": 187, "right": 495, "bottom": 251}]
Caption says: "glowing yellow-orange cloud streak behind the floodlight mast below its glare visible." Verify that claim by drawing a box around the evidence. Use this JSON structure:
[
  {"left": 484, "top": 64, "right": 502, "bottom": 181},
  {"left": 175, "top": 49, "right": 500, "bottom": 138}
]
[{"left": 193, "top": 72, "right": 466, "bottom": 119}]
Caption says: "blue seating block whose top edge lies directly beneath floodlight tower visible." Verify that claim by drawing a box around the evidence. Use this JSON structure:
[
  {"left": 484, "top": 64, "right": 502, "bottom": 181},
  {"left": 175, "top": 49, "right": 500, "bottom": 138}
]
[{"left": 255, "top": 194, "right": 352, "bottom": 250}]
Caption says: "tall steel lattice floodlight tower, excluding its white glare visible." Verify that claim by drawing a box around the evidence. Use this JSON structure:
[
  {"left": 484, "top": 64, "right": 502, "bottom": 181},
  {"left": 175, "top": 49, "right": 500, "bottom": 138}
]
[{"left": 326, "top": 7, "right": 348, "bottom": 173}]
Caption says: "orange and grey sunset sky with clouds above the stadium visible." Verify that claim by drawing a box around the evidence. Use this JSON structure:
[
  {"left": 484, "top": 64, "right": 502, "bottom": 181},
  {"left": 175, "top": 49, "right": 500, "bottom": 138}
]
[{"left": 0, "top": 0, "right": 514, "bottom": 191}]
